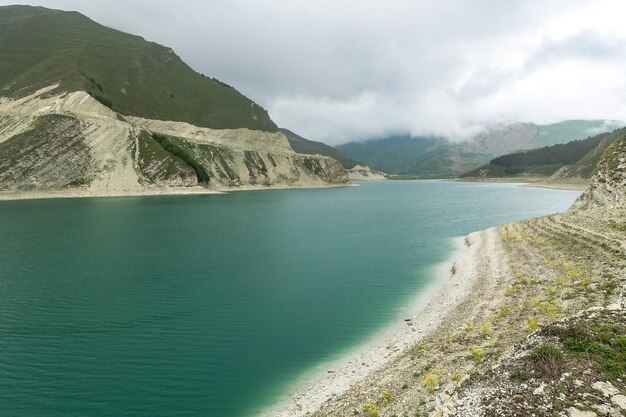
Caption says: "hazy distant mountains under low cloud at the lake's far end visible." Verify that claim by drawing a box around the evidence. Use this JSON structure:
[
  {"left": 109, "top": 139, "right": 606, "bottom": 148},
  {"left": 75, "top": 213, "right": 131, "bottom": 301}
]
[{"left": 338, "top": 120, "right": 620, "bottom": 177}]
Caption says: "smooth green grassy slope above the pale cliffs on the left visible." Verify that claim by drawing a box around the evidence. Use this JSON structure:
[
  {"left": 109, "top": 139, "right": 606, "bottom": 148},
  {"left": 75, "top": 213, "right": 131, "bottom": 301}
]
[{"left": 0, "top": 6, "right": 277, "bottom": 131}]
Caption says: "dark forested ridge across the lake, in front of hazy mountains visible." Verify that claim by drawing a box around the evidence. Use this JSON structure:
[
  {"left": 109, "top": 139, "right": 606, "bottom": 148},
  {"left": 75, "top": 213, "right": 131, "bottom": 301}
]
[{"left": 461, "top": 131, "right": 618, "bottom": 178}]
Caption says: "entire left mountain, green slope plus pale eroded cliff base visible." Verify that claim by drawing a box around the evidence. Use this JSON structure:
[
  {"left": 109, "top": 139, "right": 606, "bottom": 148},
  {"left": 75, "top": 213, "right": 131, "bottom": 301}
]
[{"left": 0, "top": 6, "right": 348, "bottom": 195}]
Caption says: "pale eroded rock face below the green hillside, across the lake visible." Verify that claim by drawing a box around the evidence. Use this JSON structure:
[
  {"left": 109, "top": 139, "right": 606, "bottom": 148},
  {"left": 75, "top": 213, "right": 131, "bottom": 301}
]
[{"left": 0, "top": 86, "right": 348, "bottom": 195}]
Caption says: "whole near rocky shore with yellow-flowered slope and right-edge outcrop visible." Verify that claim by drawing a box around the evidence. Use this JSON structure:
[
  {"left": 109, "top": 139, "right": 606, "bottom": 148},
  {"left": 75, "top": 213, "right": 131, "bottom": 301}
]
[{"left": 267, "top": 139, "right": 626, "bottom": 417}]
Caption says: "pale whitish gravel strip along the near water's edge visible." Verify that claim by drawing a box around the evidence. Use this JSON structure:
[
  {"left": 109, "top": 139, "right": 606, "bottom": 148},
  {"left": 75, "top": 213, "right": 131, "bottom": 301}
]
[{"left": 254, "top": 231, "right": 486, "bottom": 417}]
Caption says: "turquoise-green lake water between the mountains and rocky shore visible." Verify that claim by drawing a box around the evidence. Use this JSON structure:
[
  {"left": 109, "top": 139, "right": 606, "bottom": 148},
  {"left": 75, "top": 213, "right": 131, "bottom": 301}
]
[{"left": 0, "top": 181, "right": 578, "bottom": 417}]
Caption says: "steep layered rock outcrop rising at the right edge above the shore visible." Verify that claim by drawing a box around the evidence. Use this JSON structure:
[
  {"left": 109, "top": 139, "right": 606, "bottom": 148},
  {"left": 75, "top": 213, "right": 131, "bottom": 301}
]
[{"left": 572, "top": 137, "right": 626, "bottom": 209}]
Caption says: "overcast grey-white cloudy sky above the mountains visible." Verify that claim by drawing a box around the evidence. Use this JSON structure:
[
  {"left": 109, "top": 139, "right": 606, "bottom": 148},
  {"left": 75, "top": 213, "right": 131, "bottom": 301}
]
[{"left": 0, "top": 0, "right": 626, "bottom": 144}]
